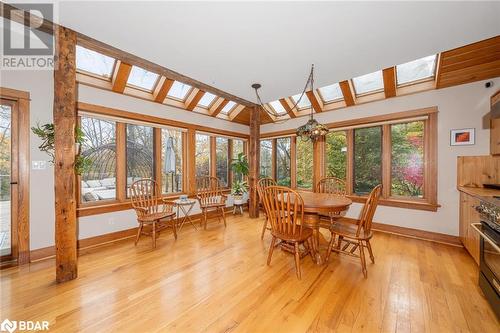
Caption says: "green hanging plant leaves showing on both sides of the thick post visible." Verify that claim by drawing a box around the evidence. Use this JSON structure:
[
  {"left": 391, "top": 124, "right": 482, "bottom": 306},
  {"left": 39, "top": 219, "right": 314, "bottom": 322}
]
[{"left": 31, "top": 123, "right": 92, "bottom": 175}]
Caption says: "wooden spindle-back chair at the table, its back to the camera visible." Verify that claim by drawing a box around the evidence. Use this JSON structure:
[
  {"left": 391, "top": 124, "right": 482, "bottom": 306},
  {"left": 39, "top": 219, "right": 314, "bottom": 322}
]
[{"left": 263, "top": 186, "right": 315, "bottom": 280}]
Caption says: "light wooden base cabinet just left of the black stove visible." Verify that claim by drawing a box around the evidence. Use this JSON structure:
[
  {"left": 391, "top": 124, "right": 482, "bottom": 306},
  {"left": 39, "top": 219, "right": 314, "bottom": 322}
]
[{"left": 459, "top": 192, "right": 480, "bottom": 265}]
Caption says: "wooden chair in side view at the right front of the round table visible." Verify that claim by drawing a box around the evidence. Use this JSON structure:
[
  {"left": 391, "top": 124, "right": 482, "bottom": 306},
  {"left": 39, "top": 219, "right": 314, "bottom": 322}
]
[{"left": 326, "top": 185, "right": 382, "bottom": 278}]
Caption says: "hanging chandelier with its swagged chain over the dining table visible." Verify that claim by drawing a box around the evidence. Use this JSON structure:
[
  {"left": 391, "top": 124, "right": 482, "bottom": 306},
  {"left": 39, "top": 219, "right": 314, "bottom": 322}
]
[{"left": 252, "top": 64, "right": 329, "bottom": 142}]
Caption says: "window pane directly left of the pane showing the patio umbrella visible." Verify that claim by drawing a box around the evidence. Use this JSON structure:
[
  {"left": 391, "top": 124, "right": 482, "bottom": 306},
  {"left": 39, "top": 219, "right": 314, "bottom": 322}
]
[{"left": 127, "top": 124, "right": 154, "bottom": 195}]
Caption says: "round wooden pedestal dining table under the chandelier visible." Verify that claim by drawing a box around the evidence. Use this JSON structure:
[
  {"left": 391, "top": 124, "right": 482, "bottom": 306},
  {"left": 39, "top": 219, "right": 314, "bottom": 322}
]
[{"left": 291, "top": 191, "right": 352, "bottom": 265}]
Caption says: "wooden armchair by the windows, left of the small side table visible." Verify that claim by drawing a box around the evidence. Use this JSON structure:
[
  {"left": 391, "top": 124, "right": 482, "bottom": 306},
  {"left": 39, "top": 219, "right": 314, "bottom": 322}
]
[{"left": 130, "top": 179, "right": 177, "bottom": 248}]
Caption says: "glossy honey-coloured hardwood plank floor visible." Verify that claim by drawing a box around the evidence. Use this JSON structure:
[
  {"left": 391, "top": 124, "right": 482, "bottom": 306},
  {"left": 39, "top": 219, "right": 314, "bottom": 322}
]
[{"left": 0, "top": 216, "right": 499, "bottom": 333}]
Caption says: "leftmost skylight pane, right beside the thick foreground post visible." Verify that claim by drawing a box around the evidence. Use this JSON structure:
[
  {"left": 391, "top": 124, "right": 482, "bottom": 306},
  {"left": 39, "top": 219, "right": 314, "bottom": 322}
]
[{"left": 76, "top": 45, "right": 116, "bottom": 79}]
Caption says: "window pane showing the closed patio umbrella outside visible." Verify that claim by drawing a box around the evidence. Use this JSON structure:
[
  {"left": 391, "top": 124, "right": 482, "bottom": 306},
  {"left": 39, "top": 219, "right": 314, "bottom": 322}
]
[{"left": 161, "top": 128, "right": 182, "bottom": 194}]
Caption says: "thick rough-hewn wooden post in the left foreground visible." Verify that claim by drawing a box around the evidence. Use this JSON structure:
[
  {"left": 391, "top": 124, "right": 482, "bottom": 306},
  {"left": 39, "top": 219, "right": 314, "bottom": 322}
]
[{"left": 54, "top": 26, "right": 78, "bottom": 282}]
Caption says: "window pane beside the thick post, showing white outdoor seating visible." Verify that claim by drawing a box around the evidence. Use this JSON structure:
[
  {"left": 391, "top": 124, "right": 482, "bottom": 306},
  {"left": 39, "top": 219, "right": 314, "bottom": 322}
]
[{"left": 80, "top": 117, "right": 116, "bottom": 202}]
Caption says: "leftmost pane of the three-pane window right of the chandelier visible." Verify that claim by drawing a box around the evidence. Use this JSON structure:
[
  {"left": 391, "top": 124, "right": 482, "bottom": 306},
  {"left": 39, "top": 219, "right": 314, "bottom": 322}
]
[{"left": 325, "top": 131, "right": 347, "bottom": 180}]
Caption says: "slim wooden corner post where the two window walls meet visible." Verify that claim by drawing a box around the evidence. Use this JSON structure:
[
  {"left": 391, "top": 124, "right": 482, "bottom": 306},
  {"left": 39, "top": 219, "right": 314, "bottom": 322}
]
[{"left": 248, "top": 107, "right": 260, "bottom": 218}]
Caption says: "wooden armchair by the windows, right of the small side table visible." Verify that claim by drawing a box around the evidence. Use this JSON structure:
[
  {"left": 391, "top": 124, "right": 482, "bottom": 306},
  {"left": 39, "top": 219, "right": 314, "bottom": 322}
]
[{"left": 196, "top": 177, "right": 227, "bottom": 229}]
